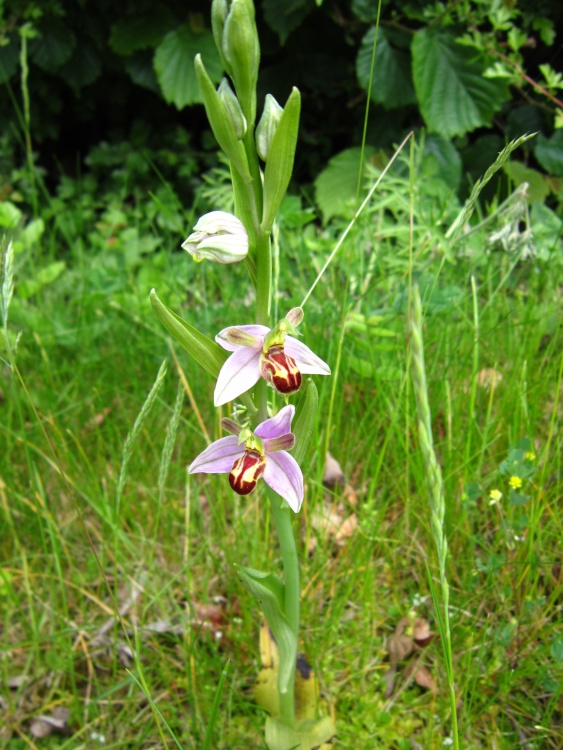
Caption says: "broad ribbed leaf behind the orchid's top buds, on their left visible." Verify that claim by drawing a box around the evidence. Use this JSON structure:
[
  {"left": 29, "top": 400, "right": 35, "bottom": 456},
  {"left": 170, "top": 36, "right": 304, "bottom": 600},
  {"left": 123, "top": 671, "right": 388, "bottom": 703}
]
[{"left": 154, "top": 25, "right": 222, "bottom": 109}]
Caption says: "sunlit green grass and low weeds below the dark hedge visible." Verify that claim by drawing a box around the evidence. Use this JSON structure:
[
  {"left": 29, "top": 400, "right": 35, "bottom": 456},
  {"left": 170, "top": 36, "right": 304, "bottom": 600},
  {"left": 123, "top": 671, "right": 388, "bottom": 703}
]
[{"left": 0, "top": 148, "right": 563, "bottom": 750}]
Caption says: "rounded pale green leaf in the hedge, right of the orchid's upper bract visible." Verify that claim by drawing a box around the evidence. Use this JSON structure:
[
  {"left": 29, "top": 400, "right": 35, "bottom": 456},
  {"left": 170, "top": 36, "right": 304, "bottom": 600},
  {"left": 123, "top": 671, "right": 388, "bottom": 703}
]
[{"left": 315, "top": 147, "right": 374, "bottom": 223}]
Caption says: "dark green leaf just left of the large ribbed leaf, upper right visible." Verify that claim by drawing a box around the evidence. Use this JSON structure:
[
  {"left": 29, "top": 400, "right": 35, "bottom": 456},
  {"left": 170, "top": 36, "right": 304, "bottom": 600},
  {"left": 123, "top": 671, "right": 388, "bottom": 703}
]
[{"left": 356, "top": 28, "right": 416, "bottom": 109}]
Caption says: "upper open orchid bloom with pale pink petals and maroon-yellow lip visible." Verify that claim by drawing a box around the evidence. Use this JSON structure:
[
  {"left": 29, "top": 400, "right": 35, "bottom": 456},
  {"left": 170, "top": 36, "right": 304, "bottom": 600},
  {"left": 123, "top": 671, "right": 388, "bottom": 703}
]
[{"left": 215, "top": 307, "right": 330, "bottom": 406}]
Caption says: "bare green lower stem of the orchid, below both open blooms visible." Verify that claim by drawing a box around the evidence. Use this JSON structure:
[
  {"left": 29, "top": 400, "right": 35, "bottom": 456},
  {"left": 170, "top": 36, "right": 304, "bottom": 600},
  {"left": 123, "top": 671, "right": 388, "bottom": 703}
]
[{"left": 267, "top": 489, "right": 300, "bottom": 727}]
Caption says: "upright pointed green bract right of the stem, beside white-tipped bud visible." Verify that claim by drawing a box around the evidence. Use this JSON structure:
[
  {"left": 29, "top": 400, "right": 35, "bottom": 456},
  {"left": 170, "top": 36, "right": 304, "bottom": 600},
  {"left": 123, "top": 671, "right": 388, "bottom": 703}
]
[{"left": 262, "top": 87, "right": 301, "bottom": 232}]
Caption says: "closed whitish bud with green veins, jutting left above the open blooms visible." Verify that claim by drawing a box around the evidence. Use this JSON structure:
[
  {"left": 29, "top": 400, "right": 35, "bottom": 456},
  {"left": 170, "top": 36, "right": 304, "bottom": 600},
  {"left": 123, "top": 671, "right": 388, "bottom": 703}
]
[{"left": 182, "top": 211, "right": 248, "bottom": 263}]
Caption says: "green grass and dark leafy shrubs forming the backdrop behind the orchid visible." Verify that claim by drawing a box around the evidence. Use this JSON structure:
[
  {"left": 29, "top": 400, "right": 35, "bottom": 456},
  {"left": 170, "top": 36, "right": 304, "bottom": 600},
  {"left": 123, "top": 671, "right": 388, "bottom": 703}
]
[{"left": 0, "top": 0, "right": 563, "bottom": 750}]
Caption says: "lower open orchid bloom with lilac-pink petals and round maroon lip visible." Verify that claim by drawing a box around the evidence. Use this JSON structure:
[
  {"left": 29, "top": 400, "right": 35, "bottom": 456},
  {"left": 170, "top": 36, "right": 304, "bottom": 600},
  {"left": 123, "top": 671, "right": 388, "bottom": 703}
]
[{"left": 188, "top": 406, "right": 303, "bottom": 513}]
